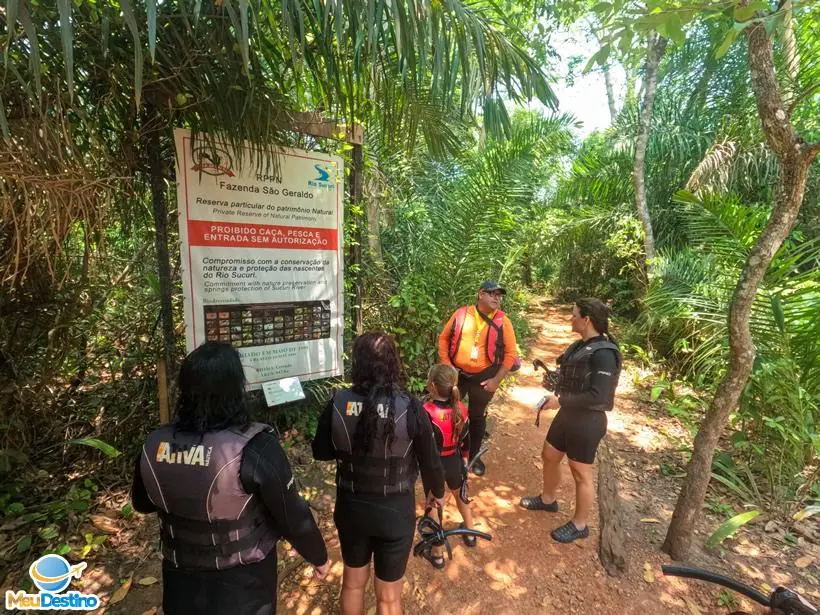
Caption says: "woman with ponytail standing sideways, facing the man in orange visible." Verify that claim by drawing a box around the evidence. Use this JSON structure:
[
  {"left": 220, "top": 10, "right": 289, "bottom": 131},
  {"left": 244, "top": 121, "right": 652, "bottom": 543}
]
[{"left": 521, "top": 298, "right": 621, "bottom": 543}]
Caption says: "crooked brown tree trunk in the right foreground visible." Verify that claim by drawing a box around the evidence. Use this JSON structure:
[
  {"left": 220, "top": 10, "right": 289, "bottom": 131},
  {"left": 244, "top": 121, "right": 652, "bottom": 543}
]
[{"left": 663, "top": 14, "right": 820, "bottom": 559}]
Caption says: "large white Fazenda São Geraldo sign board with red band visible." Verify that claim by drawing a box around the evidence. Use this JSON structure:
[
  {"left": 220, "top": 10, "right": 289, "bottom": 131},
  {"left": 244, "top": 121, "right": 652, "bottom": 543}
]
[{"left": 174, "top": 129, "right": 344, "bottom": 389}]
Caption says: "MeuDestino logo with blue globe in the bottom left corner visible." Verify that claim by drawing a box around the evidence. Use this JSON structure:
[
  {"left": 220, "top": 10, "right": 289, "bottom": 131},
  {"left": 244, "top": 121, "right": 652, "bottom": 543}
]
[{"left": 6, "top": 553, "right": 100, "bottom": 611}]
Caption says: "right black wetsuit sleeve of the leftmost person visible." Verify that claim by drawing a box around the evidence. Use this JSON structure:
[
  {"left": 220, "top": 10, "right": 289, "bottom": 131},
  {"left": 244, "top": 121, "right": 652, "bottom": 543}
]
[{"left": 239, "top": 431, "right": 327, "bottom": 566}]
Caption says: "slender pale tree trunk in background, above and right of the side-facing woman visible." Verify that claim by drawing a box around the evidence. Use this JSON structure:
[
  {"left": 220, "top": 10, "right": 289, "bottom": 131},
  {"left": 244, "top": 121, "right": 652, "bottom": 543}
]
[{"left": 632, "top": 34, "right": 666, "bottom": 277}]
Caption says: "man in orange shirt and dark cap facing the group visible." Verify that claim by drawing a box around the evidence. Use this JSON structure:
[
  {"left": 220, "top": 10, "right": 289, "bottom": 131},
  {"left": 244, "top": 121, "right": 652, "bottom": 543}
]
[{"left": 438, "top": 280, "right": 517, "bottom": 476}]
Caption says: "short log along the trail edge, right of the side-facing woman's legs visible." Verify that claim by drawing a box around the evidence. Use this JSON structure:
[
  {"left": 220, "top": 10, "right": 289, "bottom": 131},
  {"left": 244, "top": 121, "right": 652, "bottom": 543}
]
[{"left": 598, "top": 438, "right": 628, "bottom": 577}]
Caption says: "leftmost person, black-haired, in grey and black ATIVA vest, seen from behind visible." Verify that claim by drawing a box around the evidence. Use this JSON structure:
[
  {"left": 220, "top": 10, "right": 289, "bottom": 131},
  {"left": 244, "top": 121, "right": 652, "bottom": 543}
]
[{"left": 131, "top": 342, "right": 329, "bottom": 615}]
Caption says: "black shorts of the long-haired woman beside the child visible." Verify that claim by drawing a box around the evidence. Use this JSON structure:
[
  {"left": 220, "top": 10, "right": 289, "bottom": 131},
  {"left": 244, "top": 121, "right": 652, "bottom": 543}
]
[{"left": 333, "top": 490, "right": 416, "bottom": 583}]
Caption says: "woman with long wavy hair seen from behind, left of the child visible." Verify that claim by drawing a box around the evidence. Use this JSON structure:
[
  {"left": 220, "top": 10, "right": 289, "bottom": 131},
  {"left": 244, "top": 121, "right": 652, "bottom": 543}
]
[{"left": 313, "top": 333, "right": 444, "bottom": 615}]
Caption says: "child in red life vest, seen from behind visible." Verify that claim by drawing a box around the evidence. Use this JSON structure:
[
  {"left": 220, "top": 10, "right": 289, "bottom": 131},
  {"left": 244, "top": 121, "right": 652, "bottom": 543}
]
[{"left": 424, "top": 363, "right": 476, "bottom": 569}]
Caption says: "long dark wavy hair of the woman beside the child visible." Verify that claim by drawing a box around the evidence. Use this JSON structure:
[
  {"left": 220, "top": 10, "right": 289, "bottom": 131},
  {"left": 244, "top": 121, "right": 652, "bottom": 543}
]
[{"left": 350, "top": 331, "right": 406, "bottom": 454}]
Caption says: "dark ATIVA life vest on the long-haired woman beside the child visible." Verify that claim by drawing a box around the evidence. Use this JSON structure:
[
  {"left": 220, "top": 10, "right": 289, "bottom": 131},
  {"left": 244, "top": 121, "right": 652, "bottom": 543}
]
[{"left": 331, "top": 389, "right": 418, "bottom": 495}]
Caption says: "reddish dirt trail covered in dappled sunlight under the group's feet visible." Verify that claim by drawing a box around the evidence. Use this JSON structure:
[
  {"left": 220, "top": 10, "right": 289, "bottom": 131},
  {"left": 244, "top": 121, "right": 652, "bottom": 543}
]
[{"left": 102, "top": 304, "right": 812, "bottom": 615}]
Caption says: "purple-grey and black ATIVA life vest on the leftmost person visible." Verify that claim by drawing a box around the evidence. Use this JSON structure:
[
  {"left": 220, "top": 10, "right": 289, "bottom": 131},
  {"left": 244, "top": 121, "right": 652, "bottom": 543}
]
[{"left": 140, "top": 423, "right": 278, "bottom": 570}]
